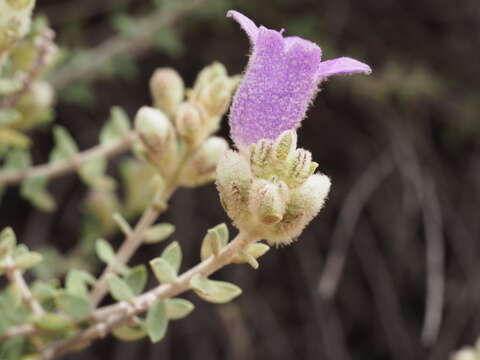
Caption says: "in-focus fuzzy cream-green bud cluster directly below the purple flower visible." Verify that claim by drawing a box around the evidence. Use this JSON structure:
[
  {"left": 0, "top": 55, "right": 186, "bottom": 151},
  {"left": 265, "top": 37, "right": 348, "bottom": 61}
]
[{"left": 217, "top": 130, "right": 330, "bottom": 245}]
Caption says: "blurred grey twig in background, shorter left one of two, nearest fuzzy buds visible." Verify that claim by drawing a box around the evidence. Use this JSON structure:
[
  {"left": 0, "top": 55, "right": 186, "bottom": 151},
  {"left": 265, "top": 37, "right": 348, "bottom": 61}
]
[{"left": 318, "top": 154, "right": 393, "bottom": 300}]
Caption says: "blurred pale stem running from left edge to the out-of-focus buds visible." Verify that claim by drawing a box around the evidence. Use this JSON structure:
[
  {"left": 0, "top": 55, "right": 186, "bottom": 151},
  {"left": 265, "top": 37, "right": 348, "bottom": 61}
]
[{"left": 0, "top": 131, "right": 137, "bottom": 184}]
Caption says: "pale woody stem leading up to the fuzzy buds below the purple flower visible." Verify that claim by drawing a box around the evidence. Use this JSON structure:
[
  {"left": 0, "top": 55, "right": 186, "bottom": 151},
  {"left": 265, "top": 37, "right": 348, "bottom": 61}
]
[{"left": 42, "top": 233, "right": 259, "bottom": 360}]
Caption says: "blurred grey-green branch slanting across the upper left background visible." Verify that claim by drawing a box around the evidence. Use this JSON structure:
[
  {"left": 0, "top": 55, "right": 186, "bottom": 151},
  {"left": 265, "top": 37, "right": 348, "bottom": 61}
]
[{"left": 52, "top": 0, "right": 203, "bottom": 90}]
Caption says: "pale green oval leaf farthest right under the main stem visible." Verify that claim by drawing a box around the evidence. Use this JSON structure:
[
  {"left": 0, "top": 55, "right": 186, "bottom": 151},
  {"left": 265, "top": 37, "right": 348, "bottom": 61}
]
[{"left": 190, "top": 274, "right": 242, "bottom": 304}]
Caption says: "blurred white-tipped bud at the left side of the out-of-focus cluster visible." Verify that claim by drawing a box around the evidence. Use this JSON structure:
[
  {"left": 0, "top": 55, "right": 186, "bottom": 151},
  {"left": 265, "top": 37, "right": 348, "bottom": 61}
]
[{"left": 135, "top": 106, "right": 178, "bottom": 176}]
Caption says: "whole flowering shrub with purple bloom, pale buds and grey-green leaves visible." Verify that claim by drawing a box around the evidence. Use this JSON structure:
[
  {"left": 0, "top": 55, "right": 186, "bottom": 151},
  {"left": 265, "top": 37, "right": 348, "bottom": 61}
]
[{"left": 0, "top": 0, "right": 371, "bottom": 359}]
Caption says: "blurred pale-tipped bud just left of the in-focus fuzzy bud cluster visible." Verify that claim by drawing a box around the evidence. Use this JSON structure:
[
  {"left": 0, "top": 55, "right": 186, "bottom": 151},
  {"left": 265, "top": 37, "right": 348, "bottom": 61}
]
[{"left": 180, "top": 137, "right": 228, "bottom": 187}]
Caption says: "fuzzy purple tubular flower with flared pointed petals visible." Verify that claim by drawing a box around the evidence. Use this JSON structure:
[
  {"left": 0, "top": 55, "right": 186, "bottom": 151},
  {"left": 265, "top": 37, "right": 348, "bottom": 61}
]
[{"left": 227, "top": 10, "right": 372, "bottom": 149}]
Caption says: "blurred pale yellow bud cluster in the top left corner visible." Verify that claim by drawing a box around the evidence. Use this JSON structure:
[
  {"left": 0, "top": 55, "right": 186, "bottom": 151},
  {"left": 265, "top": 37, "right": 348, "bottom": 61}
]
[{"left": 0, "top": 0, "right": 35, "bottom": 56}]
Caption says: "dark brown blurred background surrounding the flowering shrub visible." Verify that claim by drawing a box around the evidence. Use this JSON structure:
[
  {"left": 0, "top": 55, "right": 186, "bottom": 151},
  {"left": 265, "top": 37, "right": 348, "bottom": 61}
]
[{"left": 0, "top": 0, "right": 480, "bottom": 360}]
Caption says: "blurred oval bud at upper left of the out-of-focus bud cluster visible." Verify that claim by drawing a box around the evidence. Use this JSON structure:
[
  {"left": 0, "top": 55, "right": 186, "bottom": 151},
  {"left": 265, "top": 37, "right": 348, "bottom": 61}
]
[{"left": 150, "top": 68, "right": 185, "bottom": 117}]
